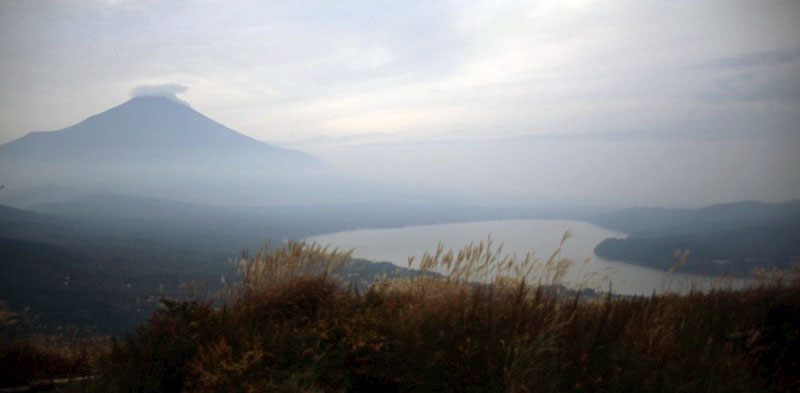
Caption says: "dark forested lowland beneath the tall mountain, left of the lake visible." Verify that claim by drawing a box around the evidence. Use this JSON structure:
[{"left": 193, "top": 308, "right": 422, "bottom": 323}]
[{"left": 0, "top": 194, "right": 534, "bottom": 334}]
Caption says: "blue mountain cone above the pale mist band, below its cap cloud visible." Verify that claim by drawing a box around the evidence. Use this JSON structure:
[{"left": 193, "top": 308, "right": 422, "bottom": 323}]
[{"left": 0, "top": 96, "right": 320, "bottom": 166}]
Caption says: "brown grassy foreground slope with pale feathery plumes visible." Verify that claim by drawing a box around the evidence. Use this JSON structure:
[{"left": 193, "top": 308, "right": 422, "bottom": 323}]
[{"left": 7, "top": 243, "right": 800, "bottom": 392}]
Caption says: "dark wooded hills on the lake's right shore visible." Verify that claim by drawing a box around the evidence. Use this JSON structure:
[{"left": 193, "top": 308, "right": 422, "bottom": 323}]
[{"left": 590, "top": 199, "right": 800, "bottom": 274}]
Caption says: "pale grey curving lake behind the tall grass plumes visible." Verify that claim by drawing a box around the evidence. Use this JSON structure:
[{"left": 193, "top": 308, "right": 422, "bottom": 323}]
[{"left": 306, "top": 220, "right": 744, "bottom": 295}]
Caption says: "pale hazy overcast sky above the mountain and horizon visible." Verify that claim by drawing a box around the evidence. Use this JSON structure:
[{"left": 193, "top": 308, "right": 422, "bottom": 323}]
[{"left": 0, "top": 0, "right": 800, "bottom": 205}]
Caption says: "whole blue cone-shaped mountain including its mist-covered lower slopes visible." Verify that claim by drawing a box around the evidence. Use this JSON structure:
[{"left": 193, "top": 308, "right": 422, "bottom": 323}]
[{"left": 0, "top": 96, "right": 337, "bottom": 206}]
